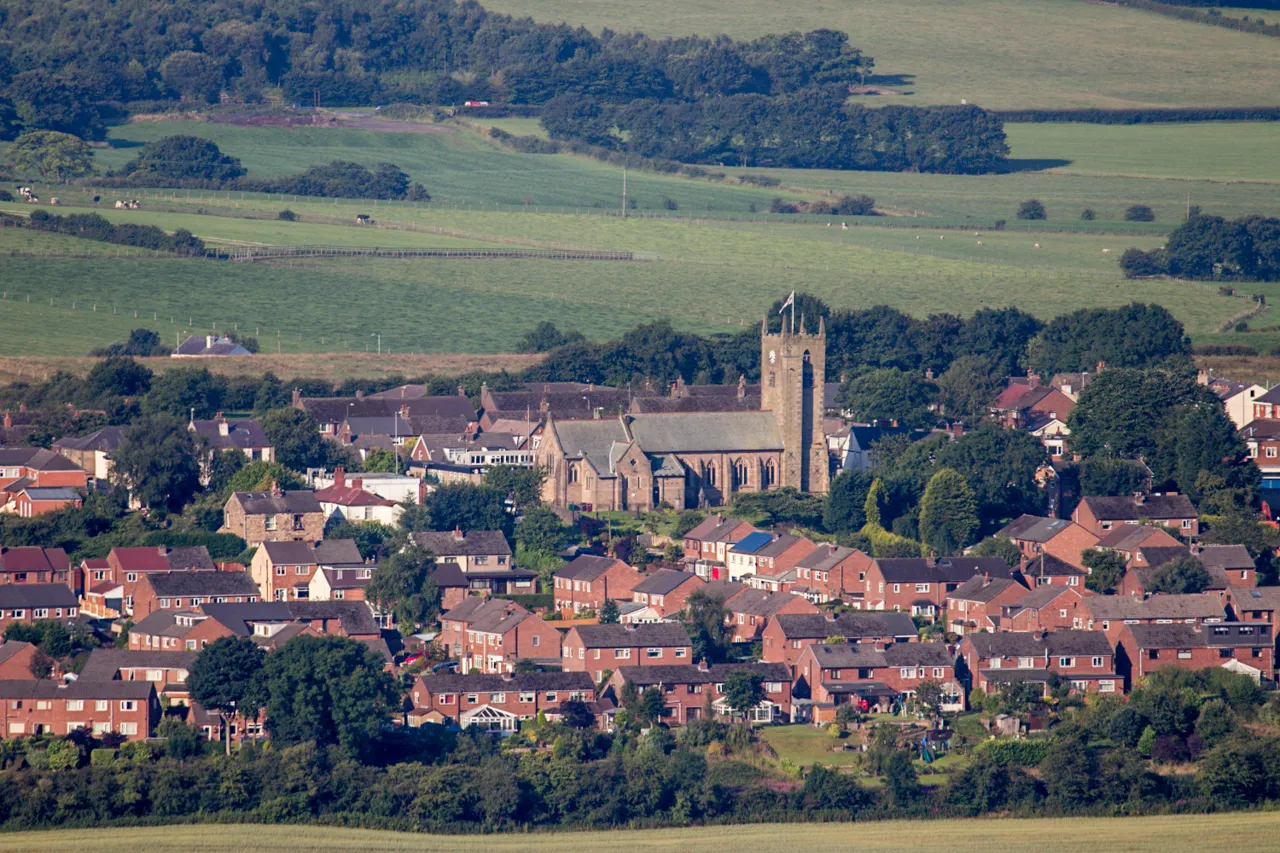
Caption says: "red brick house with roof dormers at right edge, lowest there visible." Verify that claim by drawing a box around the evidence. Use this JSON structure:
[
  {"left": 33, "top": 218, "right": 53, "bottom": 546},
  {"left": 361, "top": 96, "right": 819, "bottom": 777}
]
[{"left": 1116, "top": 622, "right": 1276, "bottom": 684}]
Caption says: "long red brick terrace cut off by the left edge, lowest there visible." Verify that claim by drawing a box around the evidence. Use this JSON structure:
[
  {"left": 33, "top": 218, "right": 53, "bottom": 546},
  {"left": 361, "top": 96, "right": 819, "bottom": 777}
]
[{"left": 0, "top": 679, "right": 160, "bottom": 740}]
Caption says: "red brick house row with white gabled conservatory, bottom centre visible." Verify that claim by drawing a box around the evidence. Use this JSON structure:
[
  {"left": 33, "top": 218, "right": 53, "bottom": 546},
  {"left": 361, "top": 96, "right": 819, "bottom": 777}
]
[{"left": 408, "top": 672, "right": 595, "bottom": 733}]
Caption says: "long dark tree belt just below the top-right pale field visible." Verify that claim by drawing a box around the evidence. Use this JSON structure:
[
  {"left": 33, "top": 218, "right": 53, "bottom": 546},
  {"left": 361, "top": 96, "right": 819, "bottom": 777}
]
[{"left": 541, "top": 86, "right": 1009, "bottom": 174}]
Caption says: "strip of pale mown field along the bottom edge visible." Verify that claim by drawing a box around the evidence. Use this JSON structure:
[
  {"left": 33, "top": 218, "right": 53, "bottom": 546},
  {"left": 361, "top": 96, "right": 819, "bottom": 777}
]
[{"left": 0, "top": 812, "right": 1280, "bottom": 853}]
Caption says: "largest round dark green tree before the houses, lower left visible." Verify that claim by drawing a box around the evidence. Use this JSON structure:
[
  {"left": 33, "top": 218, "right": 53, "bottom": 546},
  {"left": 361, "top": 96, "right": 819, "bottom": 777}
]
[{"left": 262, "top": 635, "right": 399, "bottom": 760}]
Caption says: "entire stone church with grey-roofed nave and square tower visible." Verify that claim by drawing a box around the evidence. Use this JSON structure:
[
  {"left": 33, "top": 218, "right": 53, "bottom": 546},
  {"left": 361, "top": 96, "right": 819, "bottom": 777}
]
[{"left": 538, "top": 318, "right": 831, "bottom": 511}]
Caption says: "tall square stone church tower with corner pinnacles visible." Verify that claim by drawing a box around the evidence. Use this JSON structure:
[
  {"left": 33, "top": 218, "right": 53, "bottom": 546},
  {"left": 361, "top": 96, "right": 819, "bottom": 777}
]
[{"left": 760, "top": 315, "right": 831, "bottom": 494}]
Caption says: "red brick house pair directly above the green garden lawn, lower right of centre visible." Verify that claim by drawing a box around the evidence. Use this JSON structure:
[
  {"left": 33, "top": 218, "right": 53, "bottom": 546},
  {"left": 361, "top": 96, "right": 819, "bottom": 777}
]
[{"left": 795, "top": 643, "right": 964, "bottom": 722}]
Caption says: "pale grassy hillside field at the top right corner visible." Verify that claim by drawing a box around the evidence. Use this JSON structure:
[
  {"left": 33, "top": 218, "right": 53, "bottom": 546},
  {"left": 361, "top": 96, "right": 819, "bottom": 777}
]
[{"left": 488, "top": 0, "right": 1280, "bottom": 109}]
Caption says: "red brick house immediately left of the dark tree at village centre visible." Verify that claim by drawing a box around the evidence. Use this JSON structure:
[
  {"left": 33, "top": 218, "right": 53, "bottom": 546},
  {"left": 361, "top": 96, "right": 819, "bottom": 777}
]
[{"left": 561, "top": 622, "right": 692, "bottom": 681}]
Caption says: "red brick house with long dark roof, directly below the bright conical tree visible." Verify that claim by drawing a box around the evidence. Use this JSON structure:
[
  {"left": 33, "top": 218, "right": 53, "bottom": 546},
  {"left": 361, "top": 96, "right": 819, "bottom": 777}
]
[{"left": 864, "top": 557, "right": 1014, "bottom": 616}]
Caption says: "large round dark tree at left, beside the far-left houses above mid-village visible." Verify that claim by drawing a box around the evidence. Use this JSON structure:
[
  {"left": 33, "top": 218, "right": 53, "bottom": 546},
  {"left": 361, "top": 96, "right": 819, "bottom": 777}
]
[{"left": 111, "top": 415, "right": 200, "bottom": 512}]
